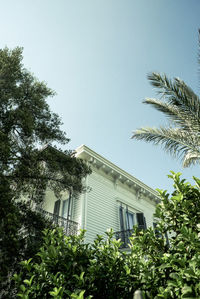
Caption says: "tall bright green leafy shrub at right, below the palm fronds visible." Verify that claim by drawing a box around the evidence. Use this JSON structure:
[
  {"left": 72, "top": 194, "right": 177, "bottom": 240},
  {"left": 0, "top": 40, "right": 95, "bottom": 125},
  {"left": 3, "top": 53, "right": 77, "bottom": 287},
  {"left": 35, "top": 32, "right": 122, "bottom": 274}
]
[{"left": 126, "top": 172, "right": 200, "bottom": 298}]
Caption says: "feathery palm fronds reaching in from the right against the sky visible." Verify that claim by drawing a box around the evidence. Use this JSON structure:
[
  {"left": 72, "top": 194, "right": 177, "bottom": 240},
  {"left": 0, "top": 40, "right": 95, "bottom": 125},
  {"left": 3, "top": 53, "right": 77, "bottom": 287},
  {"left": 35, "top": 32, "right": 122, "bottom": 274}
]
[{"left": 132, "top": 73, "right": 200, "bottom": 167}]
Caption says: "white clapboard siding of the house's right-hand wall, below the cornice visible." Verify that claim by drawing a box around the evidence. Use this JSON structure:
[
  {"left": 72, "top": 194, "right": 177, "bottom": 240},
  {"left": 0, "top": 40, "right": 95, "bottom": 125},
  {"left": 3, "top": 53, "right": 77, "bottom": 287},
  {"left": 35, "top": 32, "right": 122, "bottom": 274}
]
[{"left": 85, "top": 168, "right": 155, "bottom": 243}]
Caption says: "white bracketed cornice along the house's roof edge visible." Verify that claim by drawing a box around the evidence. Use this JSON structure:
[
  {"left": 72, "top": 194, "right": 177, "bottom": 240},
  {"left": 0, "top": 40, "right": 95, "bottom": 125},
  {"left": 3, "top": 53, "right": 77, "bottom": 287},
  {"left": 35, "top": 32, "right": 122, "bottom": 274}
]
[{"left": 76, "top": 145, "right": 160, "bottom": 203}]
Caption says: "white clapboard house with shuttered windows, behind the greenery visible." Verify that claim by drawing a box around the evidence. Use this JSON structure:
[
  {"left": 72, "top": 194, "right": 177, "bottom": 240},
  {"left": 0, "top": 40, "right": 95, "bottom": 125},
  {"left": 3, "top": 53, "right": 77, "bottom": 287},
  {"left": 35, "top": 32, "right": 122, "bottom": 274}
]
[{"left": 43, "top": 145, "right": 159, "bottom": 247}]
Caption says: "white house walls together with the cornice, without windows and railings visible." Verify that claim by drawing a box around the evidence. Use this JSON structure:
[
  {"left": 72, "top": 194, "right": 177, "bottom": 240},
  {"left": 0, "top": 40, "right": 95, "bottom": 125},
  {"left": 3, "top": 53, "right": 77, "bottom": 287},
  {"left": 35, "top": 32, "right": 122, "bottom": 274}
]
[{"left": 41, "top": 145, "right": 159, "bottom": 243}]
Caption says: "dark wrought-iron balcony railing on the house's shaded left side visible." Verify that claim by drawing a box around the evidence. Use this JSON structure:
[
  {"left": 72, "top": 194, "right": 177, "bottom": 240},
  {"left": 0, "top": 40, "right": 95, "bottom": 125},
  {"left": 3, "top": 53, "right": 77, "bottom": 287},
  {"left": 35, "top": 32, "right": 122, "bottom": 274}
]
[{"left": 36, "top": 208, "right": 78, "bottom": 236}]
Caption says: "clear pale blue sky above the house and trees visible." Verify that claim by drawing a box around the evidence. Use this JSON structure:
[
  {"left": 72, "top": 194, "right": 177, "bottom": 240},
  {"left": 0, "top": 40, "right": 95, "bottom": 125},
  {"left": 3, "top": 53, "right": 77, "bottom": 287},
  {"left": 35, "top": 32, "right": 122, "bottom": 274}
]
[{"left": 0, "top": 0, "right": 200, "bottom": 192}]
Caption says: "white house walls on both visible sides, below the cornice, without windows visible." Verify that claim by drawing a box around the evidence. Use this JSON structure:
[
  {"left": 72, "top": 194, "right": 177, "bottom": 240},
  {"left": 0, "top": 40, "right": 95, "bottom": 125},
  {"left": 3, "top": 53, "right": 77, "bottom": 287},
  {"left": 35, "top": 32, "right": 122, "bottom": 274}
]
[{"left": 43, "top": 158, "right": 156, "bottom": 243}]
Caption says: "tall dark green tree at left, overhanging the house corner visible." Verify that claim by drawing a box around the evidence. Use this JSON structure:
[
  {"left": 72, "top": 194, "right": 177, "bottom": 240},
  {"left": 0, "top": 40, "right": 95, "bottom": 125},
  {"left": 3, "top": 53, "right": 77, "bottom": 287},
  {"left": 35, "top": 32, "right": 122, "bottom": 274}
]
[{"left": 0, "top": 47, "right": 90, "bottom": 298}]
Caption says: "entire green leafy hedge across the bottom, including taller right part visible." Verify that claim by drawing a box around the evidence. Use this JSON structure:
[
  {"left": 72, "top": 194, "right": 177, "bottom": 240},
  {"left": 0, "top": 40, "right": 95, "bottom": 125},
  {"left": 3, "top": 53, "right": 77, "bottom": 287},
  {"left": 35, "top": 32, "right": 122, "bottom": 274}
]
[{"left": 14, "top": 172, "right": 200, "bottom": 299}]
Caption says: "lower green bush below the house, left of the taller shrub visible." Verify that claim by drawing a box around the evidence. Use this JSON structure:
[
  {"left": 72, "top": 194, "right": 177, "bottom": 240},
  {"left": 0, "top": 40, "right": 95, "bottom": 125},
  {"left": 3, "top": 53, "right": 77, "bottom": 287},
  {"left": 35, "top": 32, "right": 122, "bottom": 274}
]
[{"left": 14, "top": 228, "right": 131, "bottom": 298}]
